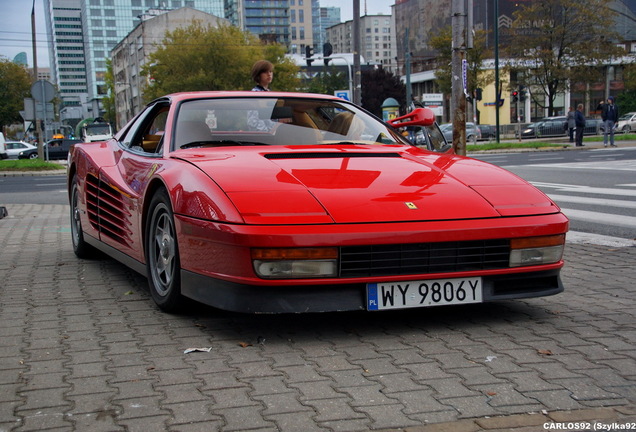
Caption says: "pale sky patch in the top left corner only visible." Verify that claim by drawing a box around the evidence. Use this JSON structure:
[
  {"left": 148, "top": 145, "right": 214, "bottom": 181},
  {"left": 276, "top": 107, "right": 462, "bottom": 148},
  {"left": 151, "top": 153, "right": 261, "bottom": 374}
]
[{"left": 0, "top": 0, "right": 49, "bottom": 68}]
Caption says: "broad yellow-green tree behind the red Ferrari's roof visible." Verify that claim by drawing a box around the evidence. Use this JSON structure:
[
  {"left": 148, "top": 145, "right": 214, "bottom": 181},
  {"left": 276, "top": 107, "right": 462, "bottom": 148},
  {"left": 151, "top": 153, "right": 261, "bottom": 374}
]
[{"left": 142, "top": 21, "right": 299, "bottom": 101}]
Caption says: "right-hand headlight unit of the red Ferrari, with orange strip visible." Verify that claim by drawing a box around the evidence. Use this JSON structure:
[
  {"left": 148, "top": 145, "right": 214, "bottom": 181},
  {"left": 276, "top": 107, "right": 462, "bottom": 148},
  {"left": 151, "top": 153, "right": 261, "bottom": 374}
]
[{"left": 509, "top": 234, "right": 565, "bottom": 267}]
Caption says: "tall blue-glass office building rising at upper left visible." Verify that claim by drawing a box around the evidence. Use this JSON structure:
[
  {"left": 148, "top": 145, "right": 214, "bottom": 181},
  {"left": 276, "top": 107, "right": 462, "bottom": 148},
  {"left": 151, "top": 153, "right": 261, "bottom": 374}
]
[{"left": 44, "top": 0, "right": 224, "bottom": 118}]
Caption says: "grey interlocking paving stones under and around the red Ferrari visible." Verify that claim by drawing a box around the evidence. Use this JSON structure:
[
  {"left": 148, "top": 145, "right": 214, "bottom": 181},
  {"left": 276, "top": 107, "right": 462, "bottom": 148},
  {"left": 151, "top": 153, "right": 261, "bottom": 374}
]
[{"left": 0, "top": 205, "right": 636, "bottom": 432}]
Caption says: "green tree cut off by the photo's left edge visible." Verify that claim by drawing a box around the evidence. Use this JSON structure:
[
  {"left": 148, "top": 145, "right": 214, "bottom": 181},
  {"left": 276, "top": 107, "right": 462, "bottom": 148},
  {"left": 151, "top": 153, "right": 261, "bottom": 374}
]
[{"left": 0, "top": 58, "right": 31, "bottom": 132}]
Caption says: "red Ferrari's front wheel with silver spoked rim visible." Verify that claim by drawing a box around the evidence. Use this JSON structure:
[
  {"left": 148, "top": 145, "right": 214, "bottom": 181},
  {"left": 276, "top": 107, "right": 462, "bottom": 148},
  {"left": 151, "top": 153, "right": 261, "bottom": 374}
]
[{"left": 145, "top": 189, "right": 183, "bottom": 312}]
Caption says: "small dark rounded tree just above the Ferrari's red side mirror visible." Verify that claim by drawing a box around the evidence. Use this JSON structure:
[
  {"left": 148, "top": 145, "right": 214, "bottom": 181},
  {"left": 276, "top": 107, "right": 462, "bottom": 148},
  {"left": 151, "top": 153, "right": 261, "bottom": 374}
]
[{"left": 360, "top": 68, "right": 406, "bottom": 118}]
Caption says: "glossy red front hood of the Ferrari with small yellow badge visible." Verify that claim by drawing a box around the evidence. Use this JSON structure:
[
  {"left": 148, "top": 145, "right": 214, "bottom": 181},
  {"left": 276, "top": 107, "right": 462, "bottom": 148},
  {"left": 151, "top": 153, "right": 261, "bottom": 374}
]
[{"left": 178, "top": 145, "right": 559, "bottom": 224}]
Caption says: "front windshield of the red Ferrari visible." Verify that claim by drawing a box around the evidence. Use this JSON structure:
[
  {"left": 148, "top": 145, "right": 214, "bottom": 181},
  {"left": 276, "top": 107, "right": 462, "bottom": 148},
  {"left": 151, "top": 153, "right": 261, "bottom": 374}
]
[{"left": 173, "top": 96, "right": 411, "bottom": 149}]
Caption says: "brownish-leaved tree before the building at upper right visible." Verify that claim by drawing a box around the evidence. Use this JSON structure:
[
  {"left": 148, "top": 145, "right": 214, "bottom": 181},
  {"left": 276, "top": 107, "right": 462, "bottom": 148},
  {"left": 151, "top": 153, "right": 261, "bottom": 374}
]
[{"left": 504, "top": 0, "right": 618, "bottom": 115}]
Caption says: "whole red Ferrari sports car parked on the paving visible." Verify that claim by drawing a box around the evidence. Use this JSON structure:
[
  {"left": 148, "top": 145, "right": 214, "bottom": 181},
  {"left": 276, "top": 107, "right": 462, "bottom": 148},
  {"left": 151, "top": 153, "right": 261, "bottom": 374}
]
[{"left": 68, "top": 92, "right": 568, "bottom": 312}]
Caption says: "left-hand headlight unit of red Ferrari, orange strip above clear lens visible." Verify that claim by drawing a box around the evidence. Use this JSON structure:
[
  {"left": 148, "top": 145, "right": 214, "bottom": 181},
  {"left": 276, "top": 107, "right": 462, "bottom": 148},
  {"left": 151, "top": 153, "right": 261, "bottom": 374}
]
[{"left": 252, "top": 248, "right": 338, "bottom": 279}]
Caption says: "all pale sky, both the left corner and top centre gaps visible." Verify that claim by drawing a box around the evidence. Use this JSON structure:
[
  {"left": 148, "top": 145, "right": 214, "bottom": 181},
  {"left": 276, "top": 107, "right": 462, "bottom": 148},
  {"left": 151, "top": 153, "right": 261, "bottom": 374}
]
[{"left": 0, "top": 0, "right": 395, "bottom": 68}]
